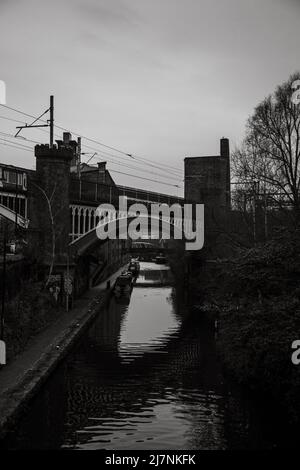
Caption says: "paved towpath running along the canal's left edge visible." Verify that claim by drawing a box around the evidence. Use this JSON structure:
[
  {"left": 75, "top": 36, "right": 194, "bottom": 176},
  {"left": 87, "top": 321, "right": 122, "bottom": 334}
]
[{"left": 0, "top": 267, "right": 124, "bottom": 437}]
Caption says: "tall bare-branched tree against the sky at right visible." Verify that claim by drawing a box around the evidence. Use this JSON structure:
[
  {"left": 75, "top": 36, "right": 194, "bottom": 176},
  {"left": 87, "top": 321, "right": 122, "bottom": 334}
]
[{"left": 232, "top": 73, "right": 300, "bottom": 219}]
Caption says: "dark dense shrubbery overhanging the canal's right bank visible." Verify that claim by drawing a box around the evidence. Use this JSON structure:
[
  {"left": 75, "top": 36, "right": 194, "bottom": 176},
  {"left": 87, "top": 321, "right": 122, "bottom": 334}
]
[{"left": 199, "top": 230, "right": 300, "bottom": 420}]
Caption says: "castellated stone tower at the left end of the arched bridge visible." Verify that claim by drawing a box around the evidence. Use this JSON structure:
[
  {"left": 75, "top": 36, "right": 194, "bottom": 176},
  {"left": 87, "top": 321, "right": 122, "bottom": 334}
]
[{"left": 35, "top": 144, "right": 74, "bottom": 267}]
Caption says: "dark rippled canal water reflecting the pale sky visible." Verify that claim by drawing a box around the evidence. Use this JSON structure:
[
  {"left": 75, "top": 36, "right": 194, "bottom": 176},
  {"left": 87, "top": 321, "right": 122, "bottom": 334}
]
[{"left": 1, "top": 263, "right": 296, "bottom": 450}]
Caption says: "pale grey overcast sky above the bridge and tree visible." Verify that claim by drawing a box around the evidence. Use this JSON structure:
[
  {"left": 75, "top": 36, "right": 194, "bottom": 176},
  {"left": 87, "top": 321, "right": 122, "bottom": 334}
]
[{"left": 0, "top": 0, "right": 300, "bottom": 194}]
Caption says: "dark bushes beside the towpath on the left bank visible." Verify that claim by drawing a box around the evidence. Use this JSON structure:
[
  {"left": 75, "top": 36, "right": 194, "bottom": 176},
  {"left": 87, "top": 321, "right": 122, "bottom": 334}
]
[{"left": 4, "top": 282, "right": 61, "bottom": 361}]
